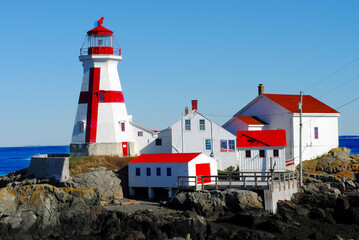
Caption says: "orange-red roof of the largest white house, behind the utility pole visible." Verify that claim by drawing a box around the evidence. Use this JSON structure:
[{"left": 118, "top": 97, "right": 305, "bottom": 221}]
[{"left": 262, "top": 94, "right": 339, "bottom": 113}]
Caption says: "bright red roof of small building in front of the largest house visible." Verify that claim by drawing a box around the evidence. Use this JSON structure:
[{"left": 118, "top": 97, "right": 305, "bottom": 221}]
[{"left": 237, "top": 130, "right": 287, "bottom": 148}]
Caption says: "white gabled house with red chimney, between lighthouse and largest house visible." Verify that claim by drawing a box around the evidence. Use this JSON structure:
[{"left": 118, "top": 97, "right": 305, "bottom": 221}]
[{"left": 141, "top": 100, "right": 237, "bottom": 170}]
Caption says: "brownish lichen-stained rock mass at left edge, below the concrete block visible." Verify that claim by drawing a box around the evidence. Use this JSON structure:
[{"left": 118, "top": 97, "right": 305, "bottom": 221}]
[{"left": 0, "top": 184, "right": 100, "bottom": 231}]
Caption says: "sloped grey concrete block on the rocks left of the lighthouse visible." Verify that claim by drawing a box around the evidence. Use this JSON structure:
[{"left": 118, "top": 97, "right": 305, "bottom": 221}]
[{"left": 26, "top": 154, "right": 70, "bottom": 182}]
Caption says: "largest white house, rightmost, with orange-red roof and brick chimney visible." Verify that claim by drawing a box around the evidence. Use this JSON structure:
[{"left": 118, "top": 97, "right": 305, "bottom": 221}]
[{"left": 223, "top": 84, "right": 340, "bottom": 164}]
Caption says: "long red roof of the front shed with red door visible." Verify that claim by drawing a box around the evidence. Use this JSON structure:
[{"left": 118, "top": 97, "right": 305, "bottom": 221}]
[{"left": 130, "top": 153, "right": 201, "bottom": 163}]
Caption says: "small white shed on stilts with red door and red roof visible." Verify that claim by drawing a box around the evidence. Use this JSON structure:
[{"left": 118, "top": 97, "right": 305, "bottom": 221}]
[{"left": 128, "top": 153, "right": 217, "bottom": 198}]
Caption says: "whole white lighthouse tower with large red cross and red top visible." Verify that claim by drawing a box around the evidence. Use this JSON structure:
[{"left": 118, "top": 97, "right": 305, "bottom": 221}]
[{"left": 70, "top": 17, "right": 134, "bottom": 156}]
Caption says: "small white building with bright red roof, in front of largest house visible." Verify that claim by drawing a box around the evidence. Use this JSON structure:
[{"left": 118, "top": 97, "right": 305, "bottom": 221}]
[{"left": 237, "top": 130, "right": 287, "bottom": 172}]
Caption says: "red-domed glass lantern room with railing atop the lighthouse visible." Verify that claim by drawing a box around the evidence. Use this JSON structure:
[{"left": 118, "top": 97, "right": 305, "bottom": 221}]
[{"left": 80, "top": 17, "right": 121, "bottom": 55}]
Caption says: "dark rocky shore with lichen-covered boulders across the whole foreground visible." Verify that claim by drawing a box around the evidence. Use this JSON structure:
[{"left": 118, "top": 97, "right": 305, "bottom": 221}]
[{"left": 0, "top": 149, "right": 359, "bottom": 240}]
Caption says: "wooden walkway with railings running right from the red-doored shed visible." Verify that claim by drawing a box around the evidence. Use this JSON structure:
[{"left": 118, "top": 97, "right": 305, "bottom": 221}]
[{"left": 177, "top": 172, "right": 298, "bottom": 191}]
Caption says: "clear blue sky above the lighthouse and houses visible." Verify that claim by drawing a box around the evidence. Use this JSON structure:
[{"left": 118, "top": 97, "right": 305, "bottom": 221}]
[{"left": 0, "top": 0, "right": 359, "bottom": 147}]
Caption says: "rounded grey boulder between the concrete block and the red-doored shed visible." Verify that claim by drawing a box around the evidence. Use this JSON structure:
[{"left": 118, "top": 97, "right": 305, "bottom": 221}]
[{"left": 68, "top": 168, "right": 123, "bottom": 200}]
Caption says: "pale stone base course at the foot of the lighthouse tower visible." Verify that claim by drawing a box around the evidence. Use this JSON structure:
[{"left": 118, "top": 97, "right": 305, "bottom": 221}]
[{"left": 70, "top": 143, "right": 134, "bottom": 157}]
